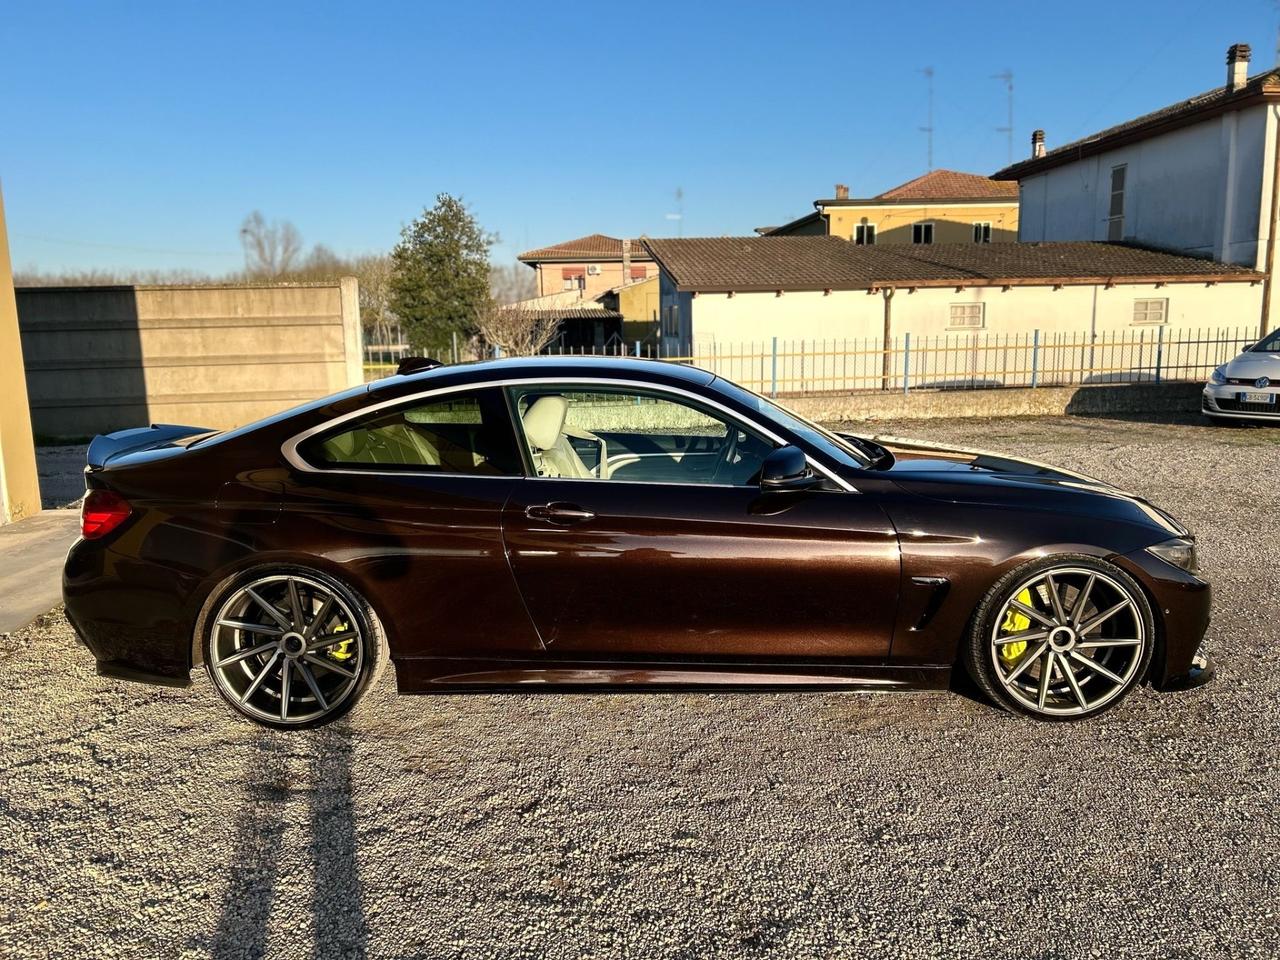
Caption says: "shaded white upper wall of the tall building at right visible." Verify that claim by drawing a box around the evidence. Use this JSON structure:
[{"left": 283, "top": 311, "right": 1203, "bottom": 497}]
[{"left": 1019, "top": 106, "right": 1276, "bottom": 269}]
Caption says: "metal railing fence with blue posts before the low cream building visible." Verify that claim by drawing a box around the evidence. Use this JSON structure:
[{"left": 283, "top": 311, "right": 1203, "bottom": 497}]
[{"left": 366, "top": 326, "right": 1257, "bottom": 397}]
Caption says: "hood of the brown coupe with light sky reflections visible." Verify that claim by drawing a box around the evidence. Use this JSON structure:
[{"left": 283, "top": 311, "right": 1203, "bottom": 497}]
[{"left": 873, "top": 436, "right": 1190, "bottom": 538}]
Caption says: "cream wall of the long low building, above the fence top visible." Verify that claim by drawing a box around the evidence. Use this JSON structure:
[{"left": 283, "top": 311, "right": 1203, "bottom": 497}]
[{"left": 684, "top": 283, "right": 1262, "bottom": 353}]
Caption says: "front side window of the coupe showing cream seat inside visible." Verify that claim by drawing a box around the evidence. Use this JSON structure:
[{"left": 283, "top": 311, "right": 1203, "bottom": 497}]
[{"left": 513, "top": 385, "right": 776, "bottom": 486}]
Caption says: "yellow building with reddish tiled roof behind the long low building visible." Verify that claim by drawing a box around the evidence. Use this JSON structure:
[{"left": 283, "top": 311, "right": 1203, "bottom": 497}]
[{"left": 759, "top": 170, "right": 1018, "bottom": 246}]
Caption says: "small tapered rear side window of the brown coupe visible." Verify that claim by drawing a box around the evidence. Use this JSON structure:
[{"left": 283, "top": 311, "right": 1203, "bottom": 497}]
[{"left": 300, "top": 389, "right": 522, "bottom": 476}]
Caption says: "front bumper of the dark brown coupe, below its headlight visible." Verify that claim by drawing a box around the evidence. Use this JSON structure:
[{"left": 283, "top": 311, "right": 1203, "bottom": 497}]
[{"left": 1116, "top": 550, "right": 1213, "bottom": 690}]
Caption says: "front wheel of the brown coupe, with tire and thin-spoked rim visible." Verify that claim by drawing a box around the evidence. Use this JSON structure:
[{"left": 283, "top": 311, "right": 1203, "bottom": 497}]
[{"left": 965, "top": 556, "right": 1155, "bottom": 719}]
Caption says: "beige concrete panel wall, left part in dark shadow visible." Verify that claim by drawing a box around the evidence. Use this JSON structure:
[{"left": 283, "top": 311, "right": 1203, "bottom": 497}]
[{"left": 18, "top": 278, "right": 364, "bottom": 436}]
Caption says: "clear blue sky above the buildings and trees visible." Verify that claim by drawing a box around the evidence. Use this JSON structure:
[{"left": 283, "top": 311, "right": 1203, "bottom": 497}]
[{"left": 0, "top": 0, "right": 1280, "bottom": 273}]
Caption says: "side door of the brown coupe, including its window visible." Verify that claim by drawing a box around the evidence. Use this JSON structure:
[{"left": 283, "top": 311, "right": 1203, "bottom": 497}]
[{"left": 503, "top": 383, "right": 899, "bottom": 662}]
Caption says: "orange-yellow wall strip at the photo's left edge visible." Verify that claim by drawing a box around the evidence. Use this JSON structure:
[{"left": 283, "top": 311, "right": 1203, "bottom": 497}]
[{"left": 0, "top": 184, "right": 40, "bottom": 524}]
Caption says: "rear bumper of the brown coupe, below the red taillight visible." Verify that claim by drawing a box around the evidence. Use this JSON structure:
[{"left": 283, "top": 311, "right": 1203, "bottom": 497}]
[{"left": 63, "top": 540, "right": 191, "bottom": 686}]
